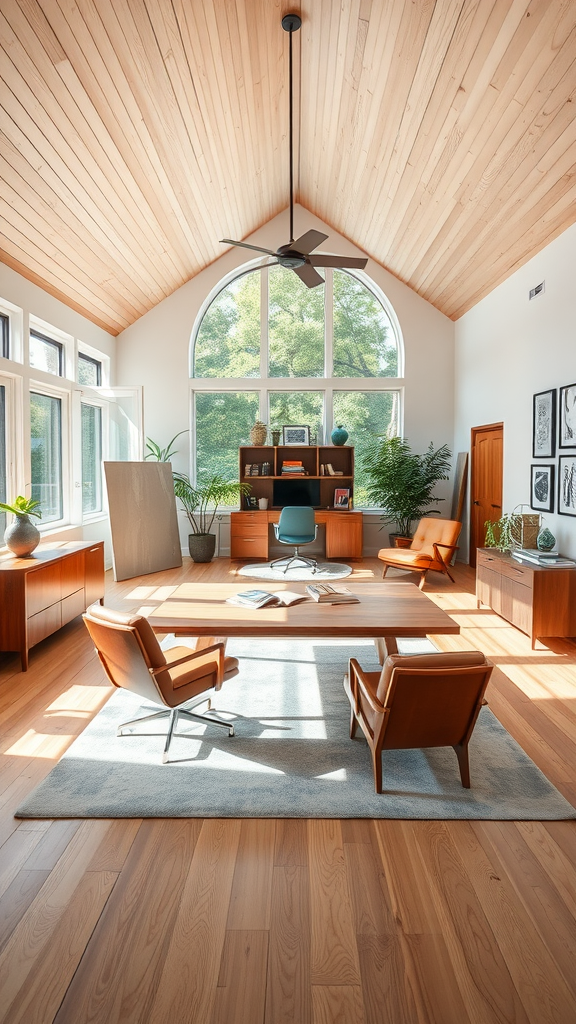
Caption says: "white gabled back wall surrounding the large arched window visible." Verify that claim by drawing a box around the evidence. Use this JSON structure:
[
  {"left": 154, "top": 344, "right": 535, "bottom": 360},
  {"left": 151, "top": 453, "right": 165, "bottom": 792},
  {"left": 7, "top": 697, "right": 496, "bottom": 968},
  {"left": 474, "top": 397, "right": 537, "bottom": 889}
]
[{"left": 117, "top": 206, "right": 454, "bottom": 554}]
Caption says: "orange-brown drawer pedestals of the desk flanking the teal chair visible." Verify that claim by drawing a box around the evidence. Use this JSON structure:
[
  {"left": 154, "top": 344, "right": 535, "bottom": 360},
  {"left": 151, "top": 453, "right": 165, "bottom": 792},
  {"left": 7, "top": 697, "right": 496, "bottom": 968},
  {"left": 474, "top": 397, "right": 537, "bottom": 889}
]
[{"left": 230, "top": 509, "right": 363, "bottom": 559}]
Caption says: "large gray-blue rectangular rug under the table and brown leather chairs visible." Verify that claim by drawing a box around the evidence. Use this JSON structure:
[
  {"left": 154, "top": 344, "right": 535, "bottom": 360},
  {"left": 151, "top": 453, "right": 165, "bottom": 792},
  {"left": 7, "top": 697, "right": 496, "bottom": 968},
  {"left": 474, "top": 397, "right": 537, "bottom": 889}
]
[{"left": 16, "top": 639, "right": 576, "bottom": 820}]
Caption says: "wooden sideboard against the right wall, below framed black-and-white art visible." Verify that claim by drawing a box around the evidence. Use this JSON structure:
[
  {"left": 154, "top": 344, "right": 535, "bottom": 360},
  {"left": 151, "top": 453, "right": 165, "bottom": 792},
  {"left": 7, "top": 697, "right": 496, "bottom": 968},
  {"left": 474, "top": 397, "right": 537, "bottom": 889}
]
[{"left": 476, "top": 548, "right": 576, "bottom": 648}]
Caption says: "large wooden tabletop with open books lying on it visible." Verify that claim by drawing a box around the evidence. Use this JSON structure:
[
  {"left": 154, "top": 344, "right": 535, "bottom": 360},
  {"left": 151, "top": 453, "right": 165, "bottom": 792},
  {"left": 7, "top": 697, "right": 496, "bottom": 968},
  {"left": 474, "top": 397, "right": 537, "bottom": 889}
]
[{"left": 114, "top": 580, "right": 460, "bottom": 638}]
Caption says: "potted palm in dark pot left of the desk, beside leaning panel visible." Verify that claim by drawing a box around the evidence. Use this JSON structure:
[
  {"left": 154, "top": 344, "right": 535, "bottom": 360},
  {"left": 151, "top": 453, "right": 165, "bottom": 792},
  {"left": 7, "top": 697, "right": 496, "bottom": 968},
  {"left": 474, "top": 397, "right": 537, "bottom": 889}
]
[{"left": 173, "top": 473, "right": 250, "bottom": 562}]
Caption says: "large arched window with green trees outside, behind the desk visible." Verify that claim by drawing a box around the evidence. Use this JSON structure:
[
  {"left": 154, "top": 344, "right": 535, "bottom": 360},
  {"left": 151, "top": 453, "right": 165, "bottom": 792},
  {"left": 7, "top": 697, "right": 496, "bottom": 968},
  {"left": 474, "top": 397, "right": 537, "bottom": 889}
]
[{"left": 191, "top": 264, "right": 404, "bottom": 508}]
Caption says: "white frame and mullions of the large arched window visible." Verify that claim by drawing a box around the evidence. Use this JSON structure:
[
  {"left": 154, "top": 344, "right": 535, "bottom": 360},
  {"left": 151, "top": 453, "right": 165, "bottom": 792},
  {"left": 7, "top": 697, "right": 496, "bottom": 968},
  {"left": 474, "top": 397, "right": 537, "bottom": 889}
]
[{"left": 190, "top": 259, "right": 405, "bottom": 507}]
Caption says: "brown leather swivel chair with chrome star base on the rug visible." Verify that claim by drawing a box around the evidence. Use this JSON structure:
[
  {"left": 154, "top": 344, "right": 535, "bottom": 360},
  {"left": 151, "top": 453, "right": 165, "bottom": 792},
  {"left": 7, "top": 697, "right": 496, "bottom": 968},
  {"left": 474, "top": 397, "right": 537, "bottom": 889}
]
[{"left": 82, "top": 604, "right": 238, "bottom": 764}]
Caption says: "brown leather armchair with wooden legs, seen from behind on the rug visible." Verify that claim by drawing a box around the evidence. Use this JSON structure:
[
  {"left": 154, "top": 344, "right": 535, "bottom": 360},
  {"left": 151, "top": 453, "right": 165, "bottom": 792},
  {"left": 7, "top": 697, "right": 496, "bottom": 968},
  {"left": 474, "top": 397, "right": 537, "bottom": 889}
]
[{"left": 344, "top": 650, "right": 493, "bottom": 793}]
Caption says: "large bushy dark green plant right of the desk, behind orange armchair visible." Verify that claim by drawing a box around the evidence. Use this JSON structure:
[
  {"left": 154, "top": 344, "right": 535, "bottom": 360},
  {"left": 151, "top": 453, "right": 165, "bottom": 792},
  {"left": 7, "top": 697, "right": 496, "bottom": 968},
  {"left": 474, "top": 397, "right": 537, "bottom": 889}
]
[{"left": 363, "top": 437, "right": 452, "bottom": 540}]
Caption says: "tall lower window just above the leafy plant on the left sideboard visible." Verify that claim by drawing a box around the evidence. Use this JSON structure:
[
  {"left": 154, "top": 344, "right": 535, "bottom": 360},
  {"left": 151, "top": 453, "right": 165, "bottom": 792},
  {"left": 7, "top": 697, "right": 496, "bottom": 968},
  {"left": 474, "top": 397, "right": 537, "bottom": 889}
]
[{"left": 30, "top": 392, "right": 64, "bottom": 523}]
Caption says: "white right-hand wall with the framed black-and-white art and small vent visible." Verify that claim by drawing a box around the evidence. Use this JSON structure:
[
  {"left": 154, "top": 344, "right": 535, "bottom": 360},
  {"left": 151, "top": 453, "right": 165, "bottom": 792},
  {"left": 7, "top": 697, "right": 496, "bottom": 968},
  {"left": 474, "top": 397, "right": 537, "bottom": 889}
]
[{"left": 454, "top": 225, "right": 576, "bottom": 557}]
